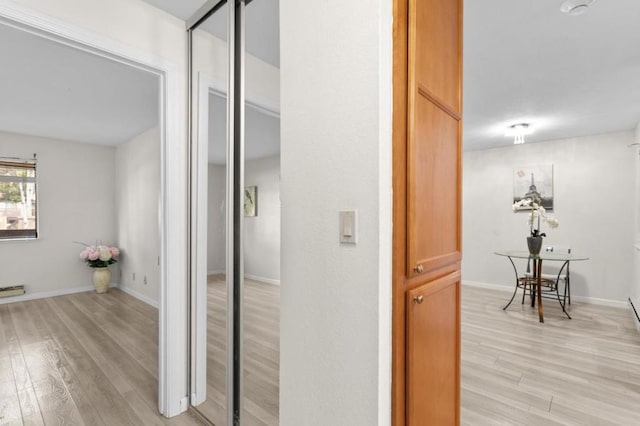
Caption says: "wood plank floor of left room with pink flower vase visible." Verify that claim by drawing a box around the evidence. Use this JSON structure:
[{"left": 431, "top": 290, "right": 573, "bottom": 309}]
[{"left": 0, "top": 289, "right": 200, "bottom": 426}]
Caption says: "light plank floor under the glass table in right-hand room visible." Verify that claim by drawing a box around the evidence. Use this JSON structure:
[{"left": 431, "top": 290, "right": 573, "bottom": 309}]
[{"left": 461, "top": 286, "right": 640, "bottom": 425}]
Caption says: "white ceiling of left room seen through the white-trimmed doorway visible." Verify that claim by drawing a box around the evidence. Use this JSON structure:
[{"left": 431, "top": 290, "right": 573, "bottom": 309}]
[{"left": 0, "top": 24, "right": 159, "bottom": 145}]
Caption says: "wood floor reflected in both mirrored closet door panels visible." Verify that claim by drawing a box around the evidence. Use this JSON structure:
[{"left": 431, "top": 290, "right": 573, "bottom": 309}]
[{"left": 197, "top": 275, "right": 280, "bottom": 426}]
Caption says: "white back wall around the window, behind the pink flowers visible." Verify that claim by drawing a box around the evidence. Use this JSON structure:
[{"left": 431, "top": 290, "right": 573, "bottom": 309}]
[{"left": 0, "top": 132, "right": 118, "bottom": 302}]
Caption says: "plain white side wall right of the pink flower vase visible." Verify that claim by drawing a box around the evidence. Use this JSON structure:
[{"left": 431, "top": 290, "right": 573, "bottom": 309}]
[{"left": 115, "top": 127, "right": 160, "bottom": 307}]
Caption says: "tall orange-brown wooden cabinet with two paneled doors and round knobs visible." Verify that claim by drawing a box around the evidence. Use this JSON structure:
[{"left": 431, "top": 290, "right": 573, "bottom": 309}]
[{"left": 393, "top": 0, "right": 462, "bottom": 426}]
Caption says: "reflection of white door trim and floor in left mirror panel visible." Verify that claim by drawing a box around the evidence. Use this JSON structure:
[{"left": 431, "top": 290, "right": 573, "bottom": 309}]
[{"left": 191, "top": 4, "right": 230, "bottom": 426}]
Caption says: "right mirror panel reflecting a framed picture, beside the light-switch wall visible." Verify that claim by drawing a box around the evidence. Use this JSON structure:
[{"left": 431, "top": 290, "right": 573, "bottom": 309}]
[{"left": 242, "top": 0, "right": 280, "bottom": 425}]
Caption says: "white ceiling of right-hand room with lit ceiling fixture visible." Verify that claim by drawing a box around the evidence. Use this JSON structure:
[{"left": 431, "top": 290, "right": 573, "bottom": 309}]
[{"left": 464, "top": 0, "right": 640, "bottom": 150}]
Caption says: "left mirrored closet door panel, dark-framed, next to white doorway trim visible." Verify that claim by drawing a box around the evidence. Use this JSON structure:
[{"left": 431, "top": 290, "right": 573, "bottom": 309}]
[{"left": 188, "top": 1, "right": 239, "bottom": 426}]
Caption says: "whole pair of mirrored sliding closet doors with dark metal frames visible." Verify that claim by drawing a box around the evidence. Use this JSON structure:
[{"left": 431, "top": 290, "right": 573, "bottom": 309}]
[{"left": 188, "top": 0, "right": 280, "bottom": 426}]
